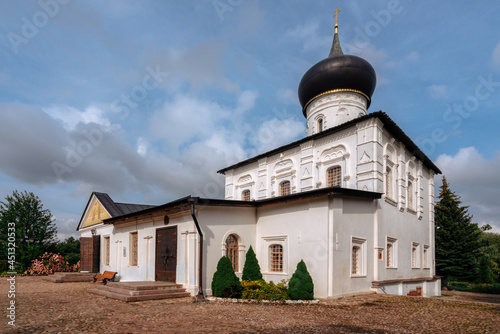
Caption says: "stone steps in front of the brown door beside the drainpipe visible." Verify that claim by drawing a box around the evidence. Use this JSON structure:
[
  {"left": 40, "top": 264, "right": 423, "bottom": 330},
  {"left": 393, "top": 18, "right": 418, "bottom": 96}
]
[{"left": 88, "top": 282, "right": 191, "bottom": 302}]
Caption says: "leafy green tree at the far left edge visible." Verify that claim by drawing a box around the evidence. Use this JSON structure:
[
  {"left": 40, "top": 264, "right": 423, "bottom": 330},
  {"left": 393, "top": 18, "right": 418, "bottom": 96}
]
[{"left": 0, "top": 190, "right": 57, "bottom": 270}]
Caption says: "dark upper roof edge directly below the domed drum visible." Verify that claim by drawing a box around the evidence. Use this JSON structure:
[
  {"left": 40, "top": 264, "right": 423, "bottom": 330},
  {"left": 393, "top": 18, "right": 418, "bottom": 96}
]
[{"left": 217, "top": 111, "right": 441, "bottom": 174}]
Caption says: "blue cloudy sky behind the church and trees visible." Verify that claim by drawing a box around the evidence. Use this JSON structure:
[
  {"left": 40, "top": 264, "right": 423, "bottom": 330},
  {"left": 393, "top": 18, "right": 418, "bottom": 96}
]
[{"left": 0, "top": 0, "right": 500, "bottom": 238}]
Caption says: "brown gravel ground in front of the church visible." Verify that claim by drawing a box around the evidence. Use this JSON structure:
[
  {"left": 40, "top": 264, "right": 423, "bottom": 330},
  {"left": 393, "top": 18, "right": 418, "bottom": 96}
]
[{"left": 0, "top": 277, "right": 500, "bottom": 333}]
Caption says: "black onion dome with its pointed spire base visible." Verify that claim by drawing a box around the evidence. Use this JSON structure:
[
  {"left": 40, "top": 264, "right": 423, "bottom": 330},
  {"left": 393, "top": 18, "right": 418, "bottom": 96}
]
[{"left": 299, "top": 32, "right": 377, "bottom": 116}]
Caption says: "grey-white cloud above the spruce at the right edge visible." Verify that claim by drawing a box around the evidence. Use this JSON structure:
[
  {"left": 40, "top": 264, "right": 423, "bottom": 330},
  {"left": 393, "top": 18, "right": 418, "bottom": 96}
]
[{"left": 436, "top": 147, "right": 500, "bottom": 233}]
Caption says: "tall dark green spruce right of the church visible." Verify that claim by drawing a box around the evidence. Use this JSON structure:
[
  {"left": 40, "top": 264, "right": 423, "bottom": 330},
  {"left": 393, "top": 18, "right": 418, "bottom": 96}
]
[{"left": 434, "top": 177, "right": 482, "bottom": 282}]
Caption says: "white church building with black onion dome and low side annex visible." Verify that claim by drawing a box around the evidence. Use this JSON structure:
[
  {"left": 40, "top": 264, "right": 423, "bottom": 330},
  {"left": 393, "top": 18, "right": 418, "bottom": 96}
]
[{"left": 77, "top": 20, "right": 441, "bottom": 298}]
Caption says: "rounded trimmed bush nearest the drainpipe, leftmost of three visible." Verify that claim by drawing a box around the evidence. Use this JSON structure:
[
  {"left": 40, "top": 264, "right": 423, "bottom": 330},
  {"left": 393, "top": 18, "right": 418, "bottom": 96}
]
[{"left": 212, "top": 256, "right": 241, "bottom": 298}]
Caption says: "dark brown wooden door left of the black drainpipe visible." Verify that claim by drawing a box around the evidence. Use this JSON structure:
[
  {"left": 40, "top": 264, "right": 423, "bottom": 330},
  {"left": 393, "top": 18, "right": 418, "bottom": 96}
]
[{"left": 155, "top": 226, "right": 177, "bottom": 283}]
